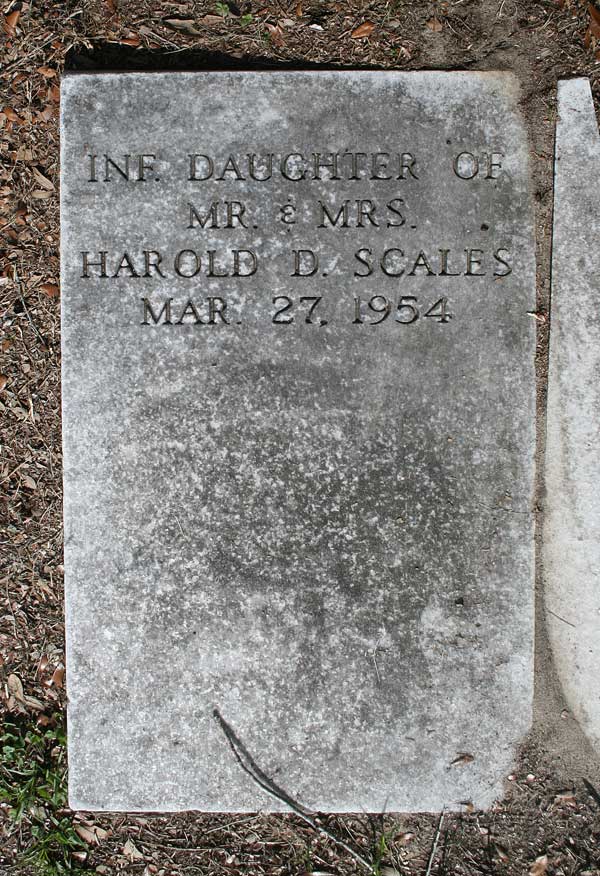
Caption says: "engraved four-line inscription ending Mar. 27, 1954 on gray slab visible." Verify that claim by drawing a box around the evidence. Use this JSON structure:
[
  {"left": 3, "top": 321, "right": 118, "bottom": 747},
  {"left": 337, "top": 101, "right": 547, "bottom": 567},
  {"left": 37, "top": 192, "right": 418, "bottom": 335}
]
[{"left": 78, "top": 141, "right": 514, "bottom": 330}]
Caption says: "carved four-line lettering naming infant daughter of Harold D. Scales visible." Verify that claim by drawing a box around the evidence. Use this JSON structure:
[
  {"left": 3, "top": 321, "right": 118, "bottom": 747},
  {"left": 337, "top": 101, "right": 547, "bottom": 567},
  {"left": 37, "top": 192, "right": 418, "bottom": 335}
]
[{"left": 81, "top": 141, "right": 513, "bottom": 328}]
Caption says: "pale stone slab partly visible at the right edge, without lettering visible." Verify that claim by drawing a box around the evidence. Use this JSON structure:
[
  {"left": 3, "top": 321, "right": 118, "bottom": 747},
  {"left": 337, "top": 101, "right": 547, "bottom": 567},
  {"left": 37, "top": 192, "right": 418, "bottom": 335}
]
[{"left": 543, "top": 79, "right": 600, "bottom": 748}]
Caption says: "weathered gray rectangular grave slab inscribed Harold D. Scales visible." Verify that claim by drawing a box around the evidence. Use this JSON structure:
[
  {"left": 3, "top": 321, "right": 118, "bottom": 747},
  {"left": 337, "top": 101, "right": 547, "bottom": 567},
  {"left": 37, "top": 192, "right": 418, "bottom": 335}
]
[{"left": 62, "top": 72, "right": 535, "bottom": 811}]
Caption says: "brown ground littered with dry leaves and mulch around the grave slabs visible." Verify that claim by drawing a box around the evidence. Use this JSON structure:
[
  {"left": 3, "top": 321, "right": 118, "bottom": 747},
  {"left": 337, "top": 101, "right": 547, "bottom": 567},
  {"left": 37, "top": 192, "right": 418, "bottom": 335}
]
[{"left": 0, "top": 0, "right": 600, "bottom": 876}]
